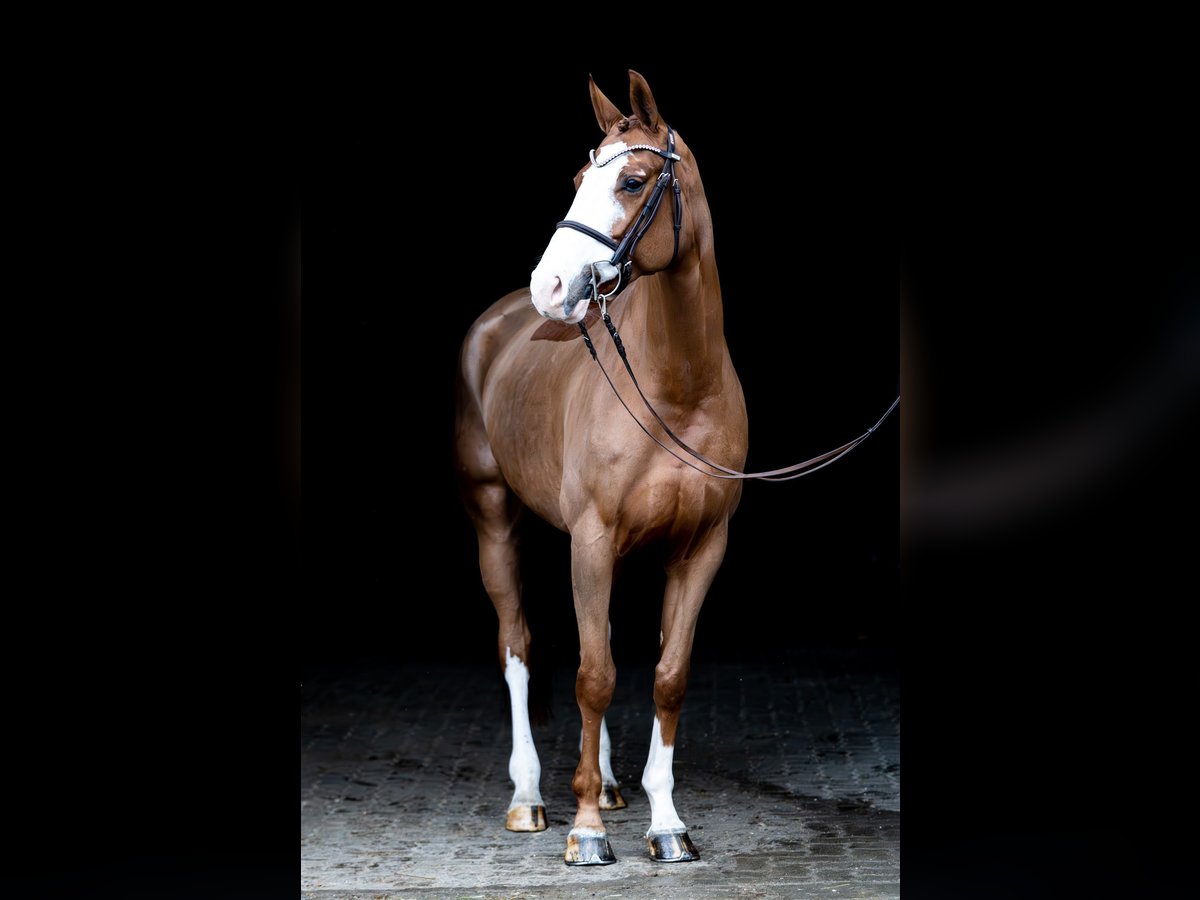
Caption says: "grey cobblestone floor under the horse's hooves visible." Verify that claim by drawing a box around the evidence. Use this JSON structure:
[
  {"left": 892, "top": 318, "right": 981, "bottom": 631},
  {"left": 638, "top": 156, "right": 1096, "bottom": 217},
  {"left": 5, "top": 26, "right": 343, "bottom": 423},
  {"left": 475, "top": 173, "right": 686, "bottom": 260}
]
[{"left": 300, "top": 654, "right": 900, "bottom": 900}]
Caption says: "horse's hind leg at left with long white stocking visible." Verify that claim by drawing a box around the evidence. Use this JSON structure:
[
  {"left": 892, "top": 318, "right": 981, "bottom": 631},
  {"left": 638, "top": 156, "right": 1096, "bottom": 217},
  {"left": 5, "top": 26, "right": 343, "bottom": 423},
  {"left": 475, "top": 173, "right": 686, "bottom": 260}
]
[{"left": 467, "top": 482, "right": 546, "bottom": 832}]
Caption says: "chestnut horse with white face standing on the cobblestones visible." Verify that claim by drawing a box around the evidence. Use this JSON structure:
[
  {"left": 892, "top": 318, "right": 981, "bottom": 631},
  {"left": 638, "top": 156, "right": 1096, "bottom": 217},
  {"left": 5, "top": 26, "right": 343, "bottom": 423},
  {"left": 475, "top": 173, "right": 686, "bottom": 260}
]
[{"left": 455, "top": 70, "right": 748, "bottom": 865}]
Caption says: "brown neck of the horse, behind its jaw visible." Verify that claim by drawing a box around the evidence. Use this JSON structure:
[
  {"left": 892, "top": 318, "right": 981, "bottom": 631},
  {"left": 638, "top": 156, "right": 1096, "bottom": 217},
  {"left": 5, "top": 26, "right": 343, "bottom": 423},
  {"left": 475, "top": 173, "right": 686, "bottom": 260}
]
[{"left": 620, "top": 217, "right": 727, "bottom": 402}]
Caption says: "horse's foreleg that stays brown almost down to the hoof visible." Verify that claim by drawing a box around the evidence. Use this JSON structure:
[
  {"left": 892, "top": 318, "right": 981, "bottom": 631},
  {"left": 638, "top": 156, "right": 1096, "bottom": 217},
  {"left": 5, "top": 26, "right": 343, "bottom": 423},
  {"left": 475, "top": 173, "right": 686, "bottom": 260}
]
[{"left": 563, "top": 526, "right": 617, "bottom": 865}]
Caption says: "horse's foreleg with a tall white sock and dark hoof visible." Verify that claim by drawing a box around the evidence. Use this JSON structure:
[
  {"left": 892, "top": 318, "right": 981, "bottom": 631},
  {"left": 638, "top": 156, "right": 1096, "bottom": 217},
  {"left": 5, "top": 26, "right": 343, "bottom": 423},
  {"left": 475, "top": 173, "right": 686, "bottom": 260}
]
[{"left": 642, "top": 524, "right": 727, "bottom": 863}]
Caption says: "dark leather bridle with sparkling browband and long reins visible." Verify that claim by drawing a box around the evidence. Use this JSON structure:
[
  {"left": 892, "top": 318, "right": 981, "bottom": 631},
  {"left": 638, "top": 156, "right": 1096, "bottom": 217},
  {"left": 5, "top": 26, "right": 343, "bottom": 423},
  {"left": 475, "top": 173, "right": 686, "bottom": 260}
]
[{"left": 556, "top": 125, "right": 900, "bottom": 481}]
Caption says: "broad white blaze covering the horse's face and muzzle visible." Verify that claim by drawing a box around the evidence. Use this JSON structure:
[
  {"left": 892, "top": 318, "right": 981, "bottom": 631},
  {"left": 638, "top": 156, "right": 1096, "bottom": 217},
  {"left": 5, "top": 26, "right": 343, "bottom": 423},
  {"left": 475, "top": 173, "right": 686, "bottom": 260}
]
[{"left": 529, "top": 140, "right": 625, "bottom": 323}]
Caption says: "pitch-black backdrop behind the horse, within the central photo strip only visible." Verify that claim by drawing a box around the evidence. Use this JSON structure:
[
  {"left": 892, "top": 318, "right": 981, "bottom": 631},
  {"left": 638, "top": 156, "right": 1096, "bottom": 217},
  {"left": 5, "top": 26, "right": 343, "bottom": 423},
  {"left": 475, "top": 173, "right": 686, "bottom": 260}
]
[{"left": 301, "top": 60, "right": 900, "bottom": 662}]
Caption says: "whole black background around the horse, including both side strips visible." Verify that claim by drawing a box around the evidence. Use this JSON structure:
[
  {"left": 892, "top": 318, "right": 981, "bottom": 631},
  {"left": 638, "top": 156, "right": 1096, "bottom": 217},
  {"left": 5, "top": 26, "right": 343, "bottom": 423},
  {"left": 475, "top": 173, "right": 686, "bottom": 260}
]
[{"left": 8, "top": 31, "right": 1200, "bottom": 896}]
